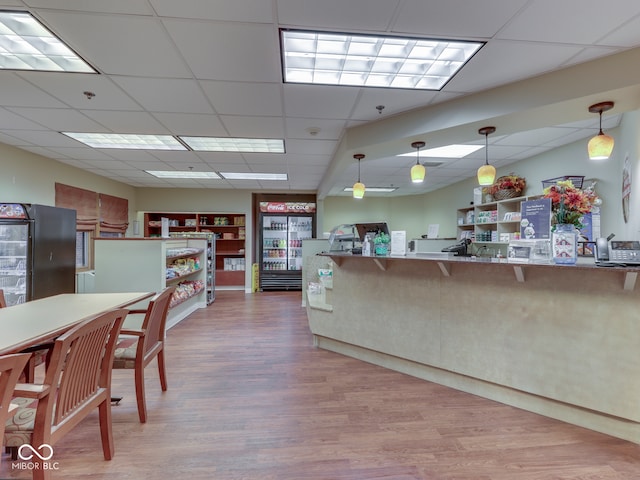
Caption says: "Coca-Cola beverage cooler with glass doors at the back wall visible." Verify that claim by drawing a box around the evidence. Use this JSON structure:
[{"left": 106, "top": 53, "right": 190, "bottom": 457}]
[{"left": 258, "top": 202, "right": 316, "bottom": 290}]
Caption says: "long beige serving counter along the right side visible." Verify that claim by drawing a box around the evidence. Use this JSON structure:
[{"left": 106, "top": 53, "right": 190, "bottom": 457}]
[{"left": 304, "top": 254, "right": 640, "bottom": 443}]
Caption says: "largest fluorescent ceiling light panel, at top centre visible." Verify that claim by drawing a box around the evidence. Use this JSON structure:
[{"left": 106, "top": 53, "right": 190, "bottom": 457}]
[{"left": 281, "top": 30, "right": 484, "bottom": 90}]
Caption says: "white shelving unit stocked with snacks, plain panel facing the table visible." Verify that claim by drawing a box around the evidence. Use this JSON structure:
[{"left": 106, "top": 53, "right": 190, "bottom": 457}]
[{"left": 95, "top": 238, "right": 207, "bottom": 328}]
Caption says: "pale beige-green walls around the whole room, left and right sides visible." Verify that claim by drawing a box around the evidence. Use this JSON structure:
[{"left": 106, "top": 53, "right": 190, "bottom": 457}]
[{"left": 0, "top": 111, "right": 640, "bottom": 255}]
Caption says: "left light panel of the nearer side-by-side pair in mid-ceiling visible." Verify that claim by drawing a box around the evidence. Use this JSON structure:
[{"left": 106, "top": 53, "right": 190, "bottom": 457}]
[{"left": 62, "top": 132, "right": 187, "bottom": 150}]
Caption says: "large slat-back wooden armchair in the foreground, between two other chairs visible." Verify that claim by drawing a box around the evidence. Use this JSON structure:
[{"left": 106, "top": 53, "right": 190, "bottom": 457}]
[{"left": 4, "top": 309, "right": 127, "bottom": 480}]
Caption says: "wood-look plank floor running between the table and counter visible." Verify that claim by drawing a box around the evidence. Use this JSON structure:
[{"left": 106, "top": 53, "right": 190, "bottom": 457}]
[{"left": 0, "top": 291, "right": 640, "bottom": 480}]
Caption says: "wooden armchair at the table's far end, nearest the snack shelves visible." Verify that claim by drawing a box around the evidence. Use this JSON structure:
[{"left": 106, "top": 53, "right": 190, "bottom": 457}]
[{"left": 113, "top": 285, "right": 176, "bottom": 423}]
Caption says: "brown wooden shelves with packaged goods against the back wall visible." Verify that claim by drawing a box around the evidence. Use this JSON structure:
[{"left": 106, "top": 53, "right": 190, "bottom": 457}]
[{"left": 144, "top": 212, "right": 246, "bottom": 286}]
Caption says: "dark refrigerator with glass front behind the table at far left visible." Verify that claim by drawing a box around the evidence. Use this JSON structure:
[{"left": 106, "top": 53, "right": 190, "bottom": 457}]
[{"left": 0, "top": 203, "right": 76, "bottom": 305}]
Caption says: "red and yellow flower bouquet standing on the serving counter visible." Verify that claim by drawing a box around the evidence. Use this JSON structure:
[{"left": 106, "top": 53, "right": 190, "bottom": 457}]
[{"left": 542, "top": 180, "right": 600, "bottom": 229}]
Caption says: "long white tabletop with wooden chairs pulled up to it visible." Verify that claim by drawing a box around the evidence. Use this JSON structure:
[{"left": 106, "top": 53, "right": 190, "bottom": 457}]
[{"left": 0, "top": 292, "right": 154, "bottom": 355}]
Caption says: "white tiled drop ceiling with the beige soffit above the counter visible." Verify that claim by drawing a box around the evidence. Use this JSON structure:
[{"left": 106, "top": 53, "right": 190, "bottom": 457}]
[{"left": 0, "top": 0, "right": 640, "bottom": 197}]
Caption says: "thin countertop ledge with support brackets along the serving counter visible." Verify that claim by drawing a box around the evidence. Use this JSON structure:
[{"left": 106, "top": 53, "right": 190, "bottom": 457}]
[{"left": 326, "top": 253, "right": 638, "bottom": 291}]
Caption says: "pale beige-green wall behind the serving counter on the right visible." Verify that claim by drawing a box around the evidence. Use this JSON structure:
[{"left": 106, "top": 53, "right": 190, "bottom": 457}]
[{"left": 323, "top": 116, "right": 640, "bottom": 239}]
